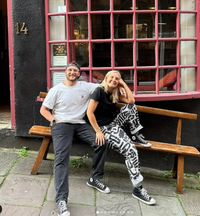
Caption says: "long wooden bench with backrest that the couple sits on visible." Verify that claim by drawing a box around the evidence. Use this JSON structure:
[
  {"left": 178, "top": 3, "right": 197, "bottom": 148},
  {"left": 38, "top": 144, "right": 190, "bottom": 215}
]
[{"left": 29, "top": 92, "right": 200, "bottom": 193}]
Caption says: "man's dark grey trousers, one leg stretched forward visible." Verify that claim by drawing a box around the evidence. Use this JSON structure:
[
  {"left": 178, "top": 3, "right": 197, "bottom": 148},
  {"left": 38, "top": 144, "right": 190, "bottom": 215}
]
[{"left": 51, "top": 123, "right": 107, "bottom": 202}]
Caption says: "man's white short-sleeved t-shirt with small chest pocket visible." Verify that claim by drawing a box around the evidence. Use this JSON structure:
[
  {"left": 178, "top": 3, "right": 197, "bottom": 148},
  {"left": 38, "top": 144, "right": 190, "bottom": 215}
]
[{"left": 43, "top": 81, "right": 99, "bottom": 124}]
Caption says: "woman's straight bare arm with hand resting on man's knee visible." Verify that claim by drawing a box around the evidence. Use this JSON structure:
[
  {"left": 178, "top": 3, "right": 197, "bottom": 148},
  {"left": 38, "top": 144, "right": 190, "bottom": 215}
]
[{"left": 87, "top": 99, "right": 106, "bottom": 145}]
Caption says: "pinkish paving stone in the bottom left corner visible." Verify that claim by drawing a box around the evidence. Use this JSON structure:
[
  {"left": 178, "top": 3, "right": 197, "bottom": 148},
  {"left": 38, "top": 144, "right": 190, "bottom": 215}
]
[{"left": 1, "top": 205, "right": 41, "bottom": 216}]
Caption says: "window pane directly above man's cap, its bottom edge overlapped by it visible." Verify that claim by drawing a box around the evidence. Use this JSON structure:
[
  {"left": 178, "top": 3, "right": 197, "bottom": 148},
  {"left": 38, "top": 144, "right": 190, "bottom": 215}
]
[{"left": 70, "top": 43, "right": 89, "bottom": 65}]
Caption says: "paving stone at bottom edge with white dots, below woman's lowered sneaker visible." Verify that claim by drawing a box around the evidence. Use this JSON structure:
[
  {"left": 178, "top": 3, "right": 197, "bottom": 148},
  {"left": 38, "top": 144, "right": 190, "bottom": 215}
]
[{"left": 96, "top": 192, "right": 142, "bottom": 216}]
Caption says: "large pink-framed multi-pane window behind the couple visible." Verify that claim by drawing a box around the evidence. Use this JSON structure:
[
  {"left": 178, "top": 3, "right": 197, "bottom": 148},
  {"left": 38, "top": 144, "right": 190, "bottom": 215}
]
[{"left": 45, "top": 0, "right": 200, "bottom": 101}]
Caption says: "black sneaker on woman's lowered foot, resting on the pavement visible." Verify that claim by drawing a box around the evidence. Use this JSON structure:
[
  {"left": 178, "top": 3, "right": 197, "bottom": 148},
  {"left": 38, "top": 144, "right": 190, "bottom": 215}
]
[{"left": 132, "top": 186, "right": 156, "bottom": 205}]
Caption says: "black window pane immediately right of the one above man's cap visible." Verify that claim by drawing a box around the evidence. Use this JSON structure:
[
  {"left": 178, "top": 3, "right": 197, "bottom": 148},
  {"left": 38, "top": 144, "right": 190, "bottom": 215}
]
[{"left": 92, "top": 43, "right": 111, "bottom": 67}]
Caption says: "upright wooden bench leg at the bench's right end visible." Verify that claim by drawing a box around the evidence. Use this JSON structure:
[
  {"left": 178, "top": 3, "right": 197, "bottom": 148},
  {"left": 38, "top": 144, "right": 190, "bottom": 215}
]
[{"left": 176, "top": 155, "right": 184, "bottom": 194}]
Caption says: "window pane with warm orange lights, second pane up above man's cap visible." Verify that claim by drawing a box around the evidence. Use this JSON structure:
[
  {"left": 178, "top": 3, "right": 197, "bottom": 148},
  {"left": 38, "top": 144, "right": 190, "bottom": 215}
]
[{"left": 69, "top": 15, "right": 88, "bottom": 40}]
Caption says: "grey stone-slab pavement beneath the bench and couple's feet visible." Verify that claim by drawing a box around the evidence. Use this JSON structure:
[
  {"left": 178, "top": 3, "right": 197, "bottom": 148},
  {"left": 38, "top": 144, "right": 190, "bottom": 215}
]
[{"left": 0, "top": 149, "right": 200, "bottom": 216}]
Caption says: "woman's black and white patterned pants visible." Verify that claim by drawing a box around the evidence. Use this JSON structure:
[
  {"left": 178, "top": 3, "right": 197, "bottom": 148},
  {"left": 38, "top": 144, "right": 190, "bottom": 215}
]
[{"left": 101, "top": 104, "right": 143, "bottom": 187}]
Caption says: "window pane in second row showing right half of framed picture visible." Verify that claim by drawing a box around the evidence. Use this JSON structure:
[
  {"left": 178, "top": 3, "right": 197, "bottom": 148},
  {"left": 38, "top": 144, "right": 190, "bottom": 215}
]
[{"left": 136, "top": 13, "right": 155, "bottom": 38}]
